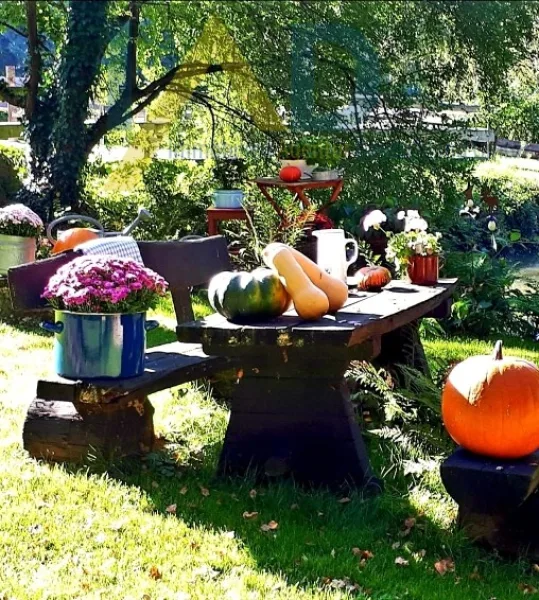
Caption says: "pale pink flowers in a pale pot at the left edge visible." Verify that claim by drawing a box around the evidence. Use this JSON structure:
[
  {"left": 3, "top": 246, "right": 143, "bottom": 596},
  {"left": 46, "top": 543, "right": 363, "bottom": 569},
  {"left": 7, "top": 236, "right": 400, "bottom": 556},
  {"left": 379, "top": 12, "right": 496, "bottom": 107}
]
[{"left": 0, "top": 204, "right": 43, "bottom": 275}]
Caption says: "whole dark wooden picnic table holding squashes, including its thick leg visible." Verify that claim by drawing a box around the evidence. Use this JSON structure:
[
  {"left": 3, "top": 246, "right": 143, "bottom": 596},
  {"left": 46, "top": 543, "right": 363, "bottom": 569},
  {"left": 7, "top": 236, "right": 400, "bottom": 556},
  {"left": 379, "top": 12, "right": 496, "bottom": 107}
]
[{"left": 177, "top": 279, "right": 456, "bottom": 489}]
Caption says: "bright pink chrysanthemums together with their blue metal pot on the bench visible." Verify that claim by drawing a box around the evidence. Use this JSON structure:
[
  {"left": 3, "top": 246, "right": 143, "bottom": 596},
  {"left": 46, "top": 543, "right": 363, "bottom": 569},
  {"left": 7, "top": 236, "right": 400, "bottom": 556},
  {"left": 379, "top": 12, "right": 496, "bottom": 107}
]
[{"left": 42, "top": 256, "right": 168, "bottom": 380}]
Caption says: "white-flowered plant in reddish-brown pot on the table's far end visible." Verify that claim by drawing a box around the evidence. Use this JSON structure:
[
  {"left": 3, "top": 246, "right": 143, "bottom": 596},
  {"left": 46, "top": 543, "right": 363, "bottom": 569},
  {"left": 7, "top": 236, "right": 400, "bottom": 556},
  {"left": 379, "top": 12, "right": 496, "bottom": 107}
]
[{"left": 386, "top": 211, "right": 442, "bottom": 285}]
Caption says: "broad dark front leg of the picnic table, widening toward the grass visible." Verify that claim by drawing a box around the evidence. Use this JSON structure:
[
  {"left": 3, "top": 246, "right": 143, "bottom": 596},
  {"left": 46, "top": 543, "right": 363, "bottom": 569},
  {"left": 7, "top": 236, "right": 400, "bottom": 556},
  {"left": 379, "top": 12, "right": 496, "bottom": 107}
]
[{"left": 218, "top": 349, "right": 381, "bottom": 492}]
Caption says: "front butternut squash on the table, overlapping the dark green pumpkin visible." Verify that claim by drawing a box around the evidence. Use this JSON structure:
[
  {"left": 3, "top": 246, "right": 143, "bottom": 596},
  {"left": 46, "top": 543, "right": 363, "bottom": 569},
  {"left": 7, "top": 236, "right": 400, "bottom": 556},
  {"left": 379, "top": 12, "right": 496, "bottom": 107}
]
[{"left": 273, "top": 248, "right": 329, "bottom": 321}]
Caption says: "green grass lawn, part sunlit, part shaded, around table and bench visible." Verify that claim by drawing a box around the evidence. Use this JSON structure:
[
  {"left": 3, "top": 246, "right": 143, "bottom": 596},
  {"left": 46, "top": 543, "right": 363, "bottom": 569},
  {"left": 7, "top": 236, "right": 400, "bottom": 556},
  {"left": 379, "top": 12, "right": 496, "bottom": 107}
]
[{"left": 0, "top": 298, "right": 539, "bottom": 600}]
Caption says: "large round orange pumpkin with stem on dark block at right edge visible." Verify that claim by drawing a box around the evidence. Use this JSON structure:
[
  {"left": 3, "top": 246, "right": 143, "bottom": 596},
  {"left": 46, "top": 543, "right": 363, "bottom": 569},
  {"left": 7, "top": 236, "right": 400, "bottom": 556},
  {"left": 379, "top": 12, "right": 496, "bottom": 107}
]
[{"left": 442, "top": 341, "right": 539, "bottom": 458}]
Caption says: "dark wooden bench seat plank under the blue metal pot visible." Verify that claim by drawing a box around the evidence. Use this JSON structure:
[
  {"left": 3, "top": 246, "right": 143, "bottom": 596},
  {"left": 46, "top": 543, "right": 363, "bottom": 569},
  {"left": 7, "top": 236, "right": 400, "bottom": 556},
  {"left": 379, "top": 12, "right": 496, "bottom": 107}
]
[{"left": 36, "top": 342, "right": 227, "bottom": 404}]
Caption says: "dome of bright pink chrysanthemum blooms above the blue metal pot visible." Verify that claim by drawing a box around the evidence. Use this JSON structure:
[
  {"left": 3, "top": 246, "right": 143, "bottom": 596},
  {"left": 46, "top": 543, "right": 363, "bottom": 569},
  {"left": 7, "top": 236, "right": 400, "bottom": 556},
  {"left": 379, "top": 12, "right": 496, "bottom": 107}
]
[{"left": 42, "top": 256, "right": 168, "bottom": 313}]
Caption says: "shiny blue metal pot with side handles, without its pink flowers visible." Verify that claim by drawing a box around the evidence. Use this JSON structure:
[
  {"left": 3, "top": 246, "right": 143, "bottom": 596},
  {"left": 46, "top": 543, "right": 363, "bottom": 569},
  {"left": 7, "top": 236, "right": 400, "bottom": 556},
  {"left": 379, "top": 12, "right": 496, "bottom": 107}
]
[{"left": 41, "top": 310, "right": 158, "bottom": 379}]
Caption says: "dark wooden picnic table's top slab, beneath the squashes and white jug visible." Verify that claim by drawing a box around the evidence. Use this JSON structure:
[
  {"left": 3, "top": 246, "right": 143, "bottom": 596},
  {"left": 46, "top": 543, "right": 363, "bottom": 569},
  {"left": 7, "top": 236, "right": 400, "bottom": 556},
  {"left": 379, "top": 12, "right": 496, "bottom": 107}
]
[{"left": 177, "top": 279, "right": 457, "bottom": 346}]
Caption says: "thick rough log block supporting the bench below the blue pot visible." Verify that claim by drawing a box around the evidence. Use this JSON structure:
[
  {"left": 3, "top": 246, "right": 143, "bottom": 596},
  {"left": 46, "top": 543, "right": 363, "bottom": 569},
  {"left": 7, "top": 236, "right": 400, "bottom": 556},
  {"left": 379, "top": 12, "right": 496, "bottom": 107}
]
[{"left": 23, "top": 396, "right": 154, "bottom": 463}]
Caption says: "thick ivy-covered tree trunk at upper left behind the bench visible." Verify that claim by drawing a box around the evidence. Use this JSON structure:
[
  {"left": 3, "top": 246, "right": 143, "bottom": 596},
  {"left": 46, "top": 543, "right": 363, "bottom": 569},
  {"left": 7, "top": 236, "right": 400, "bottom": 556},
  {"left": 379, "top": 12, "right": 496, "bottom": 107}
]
[{"left": 23, "top": 0, "right": 109, "bottom": 219}]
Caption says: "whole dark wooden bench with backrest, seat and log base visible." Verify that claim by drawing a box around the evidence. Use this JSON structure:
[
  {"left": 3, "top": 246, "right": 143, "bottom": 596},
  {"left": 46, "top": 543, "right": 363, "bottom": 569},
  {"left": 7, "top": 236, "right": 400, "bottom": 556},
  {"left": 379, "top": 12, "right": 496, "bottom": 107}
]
[{"left": 8, "top": 236, "right": 230, "bottom": 462}]
